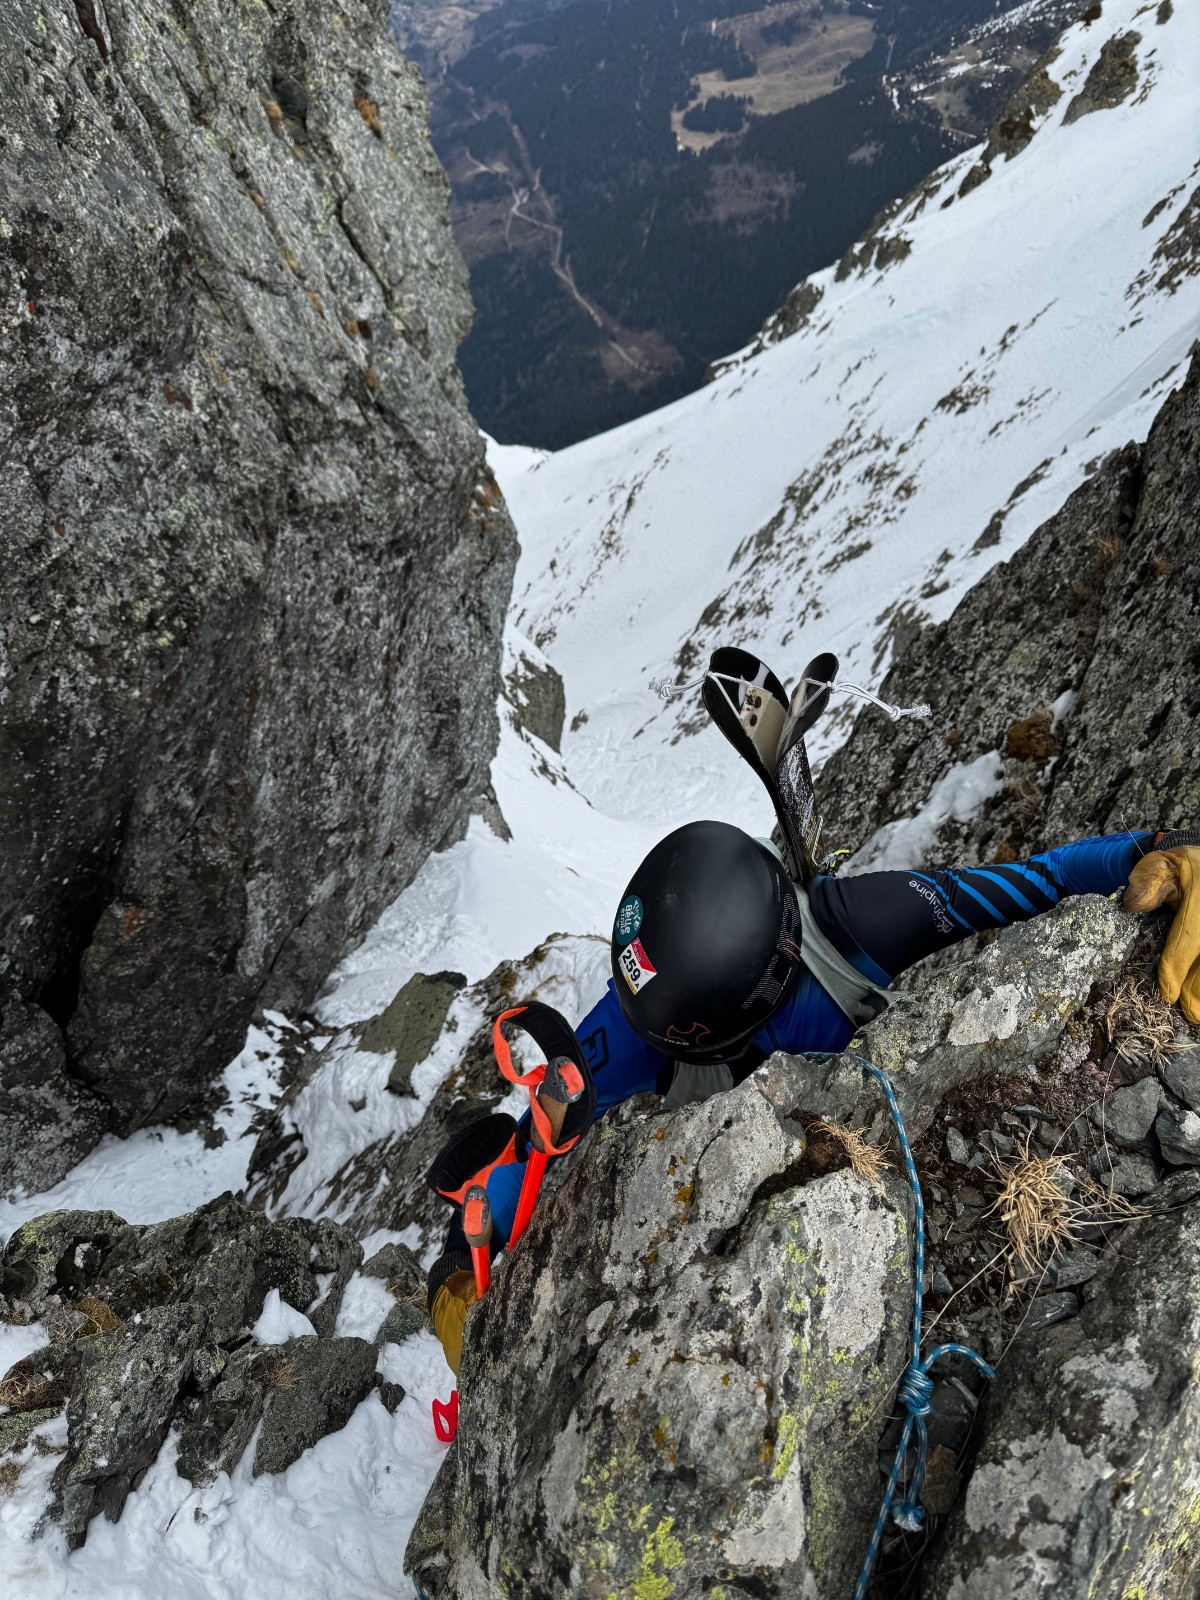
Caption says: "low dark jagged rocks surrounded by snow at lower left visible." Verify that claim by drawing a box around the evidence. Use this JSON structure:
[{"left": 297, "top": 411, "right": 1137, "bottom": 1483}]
[{"left": 0, "top": 1195, "right": 376, "bottom": 1546}]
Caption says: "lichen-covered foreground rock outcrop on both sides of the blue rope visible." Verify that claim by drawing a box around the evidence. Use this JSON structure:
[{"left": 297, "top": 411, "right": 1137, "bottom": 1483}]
[{"left": 406, "top": 896, "right": 1200, "bottom": 1600}]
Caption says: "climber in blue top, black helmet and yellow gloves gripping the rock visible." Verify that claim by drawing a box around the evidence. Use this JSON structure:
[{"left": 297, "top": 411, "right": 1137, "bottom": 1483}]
[{"left": 429, "top": 822, "right": 1200, "bottom": 1371}]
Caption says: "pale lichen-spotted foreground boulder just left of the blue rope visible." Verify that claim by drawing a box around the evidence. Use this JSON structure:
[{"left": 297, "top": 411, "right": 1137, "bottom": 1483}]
[{"left": 406, "top": 1064, "right": 912, "bottom": 1600}]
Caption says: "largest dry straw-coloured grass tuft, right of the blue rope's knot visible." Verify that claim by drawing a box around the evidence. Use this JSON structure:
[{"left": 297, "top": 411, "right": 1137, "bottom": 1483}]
[{"left": 989, "top": 1139, "right": 1146, "bottom": 1277}]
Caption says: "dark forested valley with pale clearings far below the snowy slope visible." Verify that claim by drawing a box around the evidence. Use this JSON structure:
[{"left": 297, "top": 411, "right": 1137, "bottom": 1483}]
[{"left": 394, "top": 0, "right": 1083, "bottom": 448}]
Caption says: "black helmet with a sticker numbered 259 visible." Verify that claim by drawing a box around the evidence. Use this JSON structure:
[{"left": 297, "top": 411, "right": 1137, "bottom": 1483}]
[{"left": 613, "top": 822, "right": 800, "bottom": 1062}]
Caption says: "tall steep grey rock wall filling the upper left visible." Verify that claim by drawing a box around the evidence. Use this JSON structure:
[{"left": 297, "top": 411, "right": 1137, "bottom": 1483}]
[{"left": 0, "top": 0, "right": 515, "bottom": 1184}]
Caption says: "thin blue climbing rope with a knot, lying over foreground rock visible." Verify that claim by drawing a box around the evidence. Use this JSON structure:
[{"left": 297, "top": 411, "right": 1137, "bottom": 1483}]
[{"left": 806, "top": 1051, "right": 995, "bottom": 1600}]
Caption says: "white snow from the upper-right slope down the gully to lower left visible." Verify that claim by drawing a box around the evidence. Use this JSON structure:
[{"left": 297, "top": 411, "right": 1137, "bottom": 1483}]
[{"left": 0, "top": 0, "right": 1200, "bottom": 1600}]
